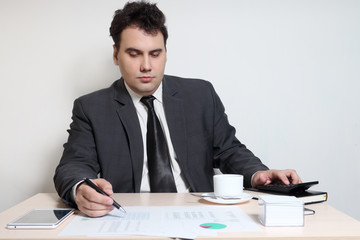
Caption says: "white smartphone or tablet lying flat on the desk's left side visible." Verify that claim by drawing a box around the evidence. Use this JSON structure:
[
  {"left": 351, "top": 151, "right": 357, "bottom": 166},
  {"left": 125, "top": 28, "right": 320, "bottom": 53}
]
[{"left": 7, "top": 208, "right": 74, "bottom": 228}]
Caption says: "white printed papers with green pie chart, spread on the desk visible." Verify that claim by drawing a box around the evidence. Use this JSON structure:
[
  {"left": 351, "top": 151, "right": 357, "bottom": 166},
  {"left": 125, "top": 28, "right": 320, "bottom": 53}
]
[{"left": 60, "top": 206, "right": 261, "bottom": 239}]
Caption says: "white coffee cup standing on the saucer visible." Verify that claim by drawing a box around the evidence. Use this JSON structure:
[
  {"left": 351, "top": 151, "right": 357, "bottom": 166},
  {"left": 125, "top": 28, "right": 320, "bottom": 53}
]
[{"left": 214, "top": 174, "right": 244, "bottom": 197}]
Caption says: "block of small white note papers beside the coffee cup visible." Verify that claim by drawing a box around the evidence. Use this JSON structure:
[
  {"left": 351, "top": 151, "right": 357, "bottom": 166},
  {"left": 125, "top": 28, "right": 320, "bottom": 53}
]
[{"left": 259, "top": 195, "right": 304, "bottom": 227}]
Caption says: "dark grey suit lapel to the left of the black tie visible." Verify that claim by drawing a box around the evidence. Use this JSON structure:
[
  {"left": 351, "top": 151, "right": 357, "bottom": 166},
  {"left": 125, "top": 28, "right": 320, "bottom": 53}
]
[{"left": 114, "top": 78, "right": 144, "bottom": 192}]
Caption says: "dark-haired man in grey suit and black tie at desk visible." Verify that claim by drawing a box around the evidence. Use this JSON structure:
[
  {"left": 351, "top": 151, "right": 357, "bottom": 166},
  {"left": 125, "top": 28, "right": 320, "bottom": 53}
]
[{"left": 54, "top": 2, "right": 301, "bottom": 217}]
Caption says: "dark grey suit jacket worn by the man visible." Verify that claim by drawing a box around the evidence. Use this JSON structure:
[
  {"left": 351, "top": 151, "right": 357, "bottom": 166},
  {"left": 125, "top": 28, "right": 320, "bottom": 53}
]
[{"left": 54, "top": 75, "right": 268, "bottom": 205}]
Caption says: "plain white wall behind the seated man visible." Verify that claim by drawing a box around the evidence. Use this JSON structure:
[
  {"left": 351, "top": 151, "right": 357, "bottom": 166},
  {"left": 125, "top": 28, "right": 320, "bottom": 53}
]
[{"left": 0, "top": 0, "right": 360, "bottom": 220}]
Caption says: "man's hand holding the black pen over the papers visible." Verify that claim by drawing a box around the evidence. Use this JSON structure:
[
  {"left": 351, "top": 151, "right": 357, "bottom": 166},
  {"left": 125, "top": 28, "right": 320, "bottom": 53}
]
[{"left": 75, "top": 178, "right": 114, "bottom": 217}]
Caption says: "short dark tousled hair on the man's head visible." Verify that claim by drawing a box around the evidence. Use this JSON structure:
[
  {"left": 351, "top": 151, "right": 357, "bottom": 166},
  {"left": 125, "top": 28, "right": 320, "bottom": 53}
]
[{"left": 110, "top": 1, "right": 168, "bottom": 49}]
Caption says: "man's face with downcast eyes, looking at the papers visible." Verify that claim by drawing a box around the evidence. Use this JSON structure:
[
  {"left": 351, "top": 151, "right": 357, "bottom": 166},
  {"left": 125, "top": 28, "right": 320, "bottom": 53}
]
[{"left": 113, "top": 26, "right": 166, "bottom": 96}]
